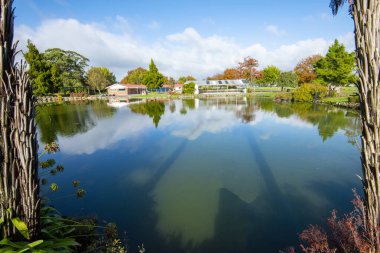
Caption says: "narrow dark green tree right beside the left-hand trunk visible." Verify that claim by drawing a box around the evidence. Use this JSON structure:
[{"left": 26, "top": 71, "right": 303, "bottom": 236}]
[{"left": 24, "top": 40, "right": 56, "bottom": 95}]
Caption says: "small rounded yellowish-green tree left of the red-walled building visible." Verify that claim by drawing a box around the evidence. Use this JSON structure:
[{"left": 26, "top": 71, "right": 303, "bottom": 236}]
[{"left": 86, "top": 67, "right": 116, "bottom": 93}]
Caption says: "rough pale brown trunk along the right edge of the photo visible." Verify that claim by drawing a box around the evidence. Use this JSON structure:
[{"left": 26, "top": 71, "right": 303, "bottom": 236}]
[{"left": 330, "top": 0, "right": 380, "bottom": 253}]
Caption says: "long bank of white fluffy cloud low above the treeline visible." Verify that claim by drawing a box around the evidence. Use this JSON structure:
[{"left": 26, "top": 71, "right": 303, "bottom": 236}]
[{"left": 15, "top": 17, "right": 353, "bottom": 78}]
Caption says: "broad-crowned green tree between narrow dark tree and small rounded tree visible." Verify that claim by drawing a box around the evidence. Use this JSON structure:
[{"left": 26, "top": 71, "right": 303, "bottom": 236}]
[{"left": 44, "top": 48, "right": 88, "bottom": 90}]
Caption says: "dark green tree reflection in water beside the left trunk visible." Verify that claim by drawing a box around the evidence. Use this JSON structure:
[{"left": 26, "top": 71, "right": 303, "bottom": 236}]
[{"left": 36, "top": 101, "right": 116, "bottom": 143}]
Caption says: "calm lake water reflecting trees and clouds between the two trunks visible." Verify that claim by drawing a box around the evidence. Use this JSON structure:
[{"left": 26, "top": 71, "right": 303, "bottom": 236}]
[{"left": 38, "top": 98, "right": 361, "bottom": 253}]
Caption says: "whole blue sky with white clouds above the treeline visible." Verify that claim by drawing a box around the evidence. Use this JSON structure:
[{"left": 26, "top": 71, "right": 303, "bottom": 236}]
[{"left": 14, "top": 0, "right": 354, "bottom": 79}]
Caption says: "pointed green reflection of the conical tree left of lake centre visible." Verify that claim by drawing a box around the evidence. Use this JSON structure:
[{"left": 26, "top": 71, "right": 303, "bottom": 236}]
[{"left": 129, "top": 101, "right": 165, "bottom": 127}]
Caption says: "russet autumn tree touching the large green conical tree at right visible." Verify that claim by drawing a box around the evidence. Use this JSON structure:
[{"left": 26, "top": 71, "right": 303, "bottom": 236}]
[{"left": 294, "top": 54, "right": 322, "bottom": 84}]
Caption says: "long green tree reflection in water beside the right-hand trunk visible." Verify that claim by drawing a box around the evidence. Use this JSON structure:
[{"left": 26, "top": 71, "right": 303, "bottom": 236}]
[{"left": 259, "top": 102, "right": 360, "bottom": 143}]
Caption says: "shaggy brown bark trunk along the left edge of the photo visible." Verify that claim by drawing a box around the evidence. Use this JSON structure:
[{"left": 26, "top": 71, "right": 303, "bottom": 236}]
[{"left": 0, "top": 0, "right": 40, "bottom": 239}]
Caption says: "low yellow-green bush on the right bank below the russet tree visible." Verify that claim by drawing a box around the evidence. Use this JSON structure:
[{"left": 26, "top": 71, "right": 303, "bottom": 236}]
[{"left": 293, "top": 84, "right": 328, "bottom": 101}]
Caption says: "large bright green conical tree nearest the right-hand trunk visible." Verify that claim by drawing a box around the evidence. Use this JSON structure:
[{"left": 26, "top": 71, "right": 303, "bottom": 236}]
[{"left": 314, "top": 40, "right": 356, "bottom": 86}]
